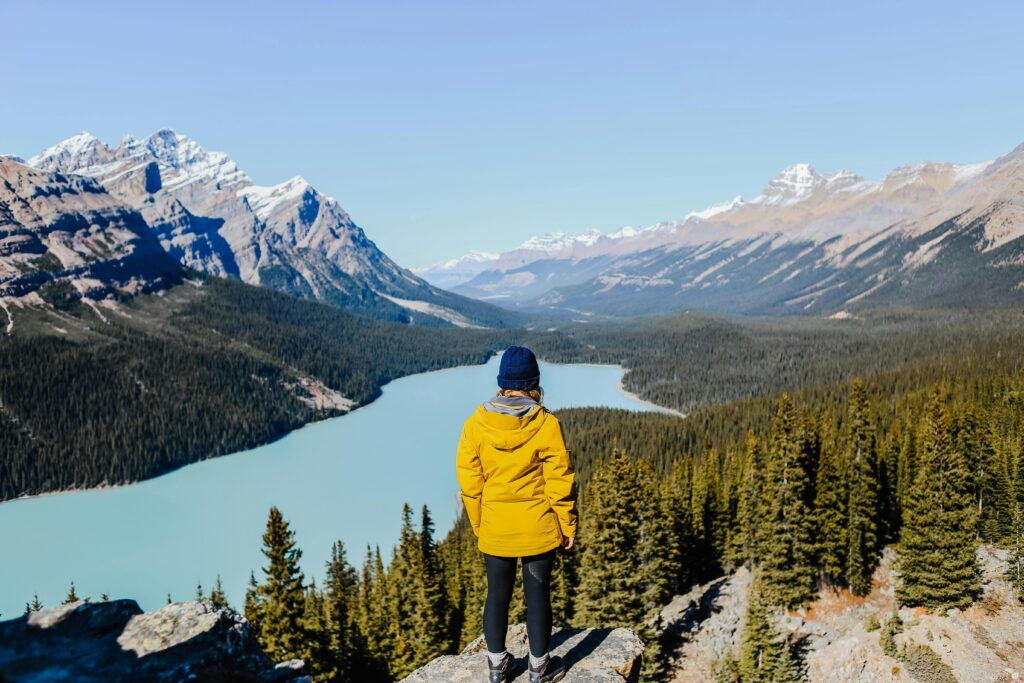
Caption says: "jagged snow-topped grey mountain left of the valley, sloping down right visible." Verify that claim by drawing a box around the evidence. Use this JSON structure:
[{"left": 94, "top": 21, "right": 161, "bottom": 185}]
[{"left": 28, "top": 129, "right": 515, "bottom": 327}]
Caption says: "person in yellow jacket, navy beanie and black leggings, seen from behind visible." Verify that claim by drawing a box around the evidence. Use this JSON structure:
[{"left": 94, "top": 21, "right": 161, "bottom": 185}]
[{"left": 456, "top": 346, "right": 577, "bottom": 683}]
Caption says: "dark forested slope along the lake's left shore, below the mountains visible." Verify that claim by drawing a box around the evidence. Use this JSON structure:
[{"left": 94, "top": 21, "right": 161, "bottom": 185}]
[{"left": 0, "top": 278, "right": 508, "bottom": 500}]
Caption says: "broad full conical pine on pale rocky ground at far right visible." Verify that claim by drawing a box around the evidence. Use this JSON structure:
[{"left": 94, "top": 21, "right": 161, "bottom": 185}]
[{"left": 896, "top": 389, "right": 981, "bottom": 609}]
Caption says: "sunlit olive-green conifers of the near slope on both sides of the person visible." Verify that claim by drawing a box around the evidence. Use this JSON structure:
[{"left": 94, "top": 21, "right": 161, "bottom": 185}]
[{"left": 199, "top": 337, "right": 1024, "bottom": 683}]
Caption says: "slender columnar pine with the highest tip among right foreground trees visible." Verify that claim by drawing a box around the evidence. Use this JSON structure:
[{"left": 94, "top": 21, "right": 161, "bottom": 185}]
[{"left": 845, "top": 380, "right": 879, "bottom": 596}]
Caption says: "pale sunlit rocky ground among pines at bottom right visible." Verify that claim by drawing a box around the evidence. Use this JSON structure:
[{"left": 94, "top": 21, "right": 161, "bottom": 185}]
[{"left": 662, "top": 548, "right": 1024, "bottom": 683}]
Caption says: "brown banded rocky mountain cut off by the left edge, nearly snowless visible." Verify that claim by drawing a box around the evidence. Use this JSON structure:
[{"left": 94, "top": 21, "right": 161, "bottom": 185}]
[{"left": 0, "top": 157, "right": 181, "bottom": 329}]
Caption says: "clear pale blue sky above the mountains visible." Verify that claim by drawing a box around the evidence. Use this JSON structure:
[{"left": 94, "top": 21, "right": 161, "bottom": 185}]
[{"left": 8, "top": 0, "right": 1024, "bottom": 266}]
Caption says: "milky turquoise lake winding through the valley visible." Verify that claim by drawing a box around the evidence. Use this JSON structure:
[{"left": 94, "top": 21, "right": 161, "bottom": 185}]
[{"left": 0, "top": 357, "right": 656, "bottom": 618}]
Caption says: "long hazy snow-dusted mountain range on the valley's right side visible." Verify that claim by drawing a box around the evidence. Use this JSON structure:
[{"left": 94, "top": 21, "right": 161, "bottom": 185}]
[{"left": 421, "top": 145, "right": 1024, "bottom": 314}]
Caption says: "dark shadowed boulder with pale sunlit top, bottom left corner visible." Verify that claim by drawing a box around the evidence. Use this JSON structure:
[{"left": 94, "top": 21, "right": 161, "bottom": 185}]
[{"left": 0, "top": 600, "right": 309, "bottom": 683}]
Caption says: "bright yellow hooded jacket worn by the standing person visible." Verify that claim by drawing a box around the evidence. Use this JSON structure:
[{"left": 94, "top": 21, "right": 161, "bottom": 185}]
[{"left": 456, "top": 405, "right": 577, "bottom": 557}]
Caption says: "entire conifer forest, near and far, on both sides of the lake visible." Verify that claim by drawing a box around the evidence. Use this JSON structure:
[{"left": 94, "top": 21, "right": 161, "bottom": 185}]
[{"left": 6, "top": 280, "right": 1024, "bottom": 683}]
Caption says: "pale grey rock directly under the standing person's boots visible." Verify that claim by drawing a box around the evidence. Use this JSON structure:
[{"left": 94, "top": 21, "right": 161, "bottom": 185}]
[{"left": 401, "top": 624, "right": 643, "bottom": 683}]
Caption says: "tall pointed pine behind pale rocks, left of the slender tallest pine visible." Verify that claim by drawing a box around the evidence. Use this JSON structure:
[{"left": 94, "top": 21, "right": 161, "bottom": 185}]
[{"left": 761, "top": 394, "right": 815, "bottom": 608}]
